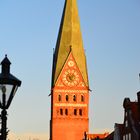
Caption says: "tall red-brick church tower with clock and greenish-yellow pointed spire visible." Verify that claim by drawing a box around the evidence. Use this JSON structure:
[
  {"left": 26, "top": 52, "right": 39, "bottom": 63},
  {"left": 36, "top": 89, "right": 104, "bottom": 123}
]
[{"left": 50, "top": 0, "right": 89, "bottom": 140}]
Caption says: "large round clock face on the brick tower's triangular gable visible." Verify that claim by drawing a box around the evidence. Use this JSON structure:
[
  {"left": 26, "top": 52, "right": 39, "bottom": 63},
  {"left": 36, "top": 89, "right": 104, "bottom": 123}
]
[{"left": 62, "top": 69, "right": 79, "bottom": 87}]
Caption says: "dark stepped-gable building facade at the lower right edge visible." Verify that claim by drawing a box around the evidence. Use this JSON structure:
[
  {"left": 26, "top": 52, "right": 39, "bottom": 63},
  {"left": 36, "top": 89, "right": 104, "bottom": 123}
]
[{"left": 114, "top": 92, "right": 140, "bottom": 140}]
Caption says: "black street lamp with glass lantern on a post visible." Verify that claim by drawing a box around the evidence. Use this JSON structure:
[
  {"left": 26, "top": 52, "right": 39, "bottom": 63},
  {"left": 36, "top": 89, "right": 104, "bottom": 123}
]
[{"left": 0, "top": 55, "right": 21, "bottom": 140}]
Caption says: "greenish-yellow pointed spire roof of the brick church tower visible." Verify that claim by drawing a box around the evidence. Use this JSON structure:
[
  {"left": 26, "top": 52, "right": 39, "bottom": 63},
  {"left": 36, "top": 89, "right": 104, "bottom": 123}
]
[{"left": 52, "top": 0, "right": 88, "bottom": 86}]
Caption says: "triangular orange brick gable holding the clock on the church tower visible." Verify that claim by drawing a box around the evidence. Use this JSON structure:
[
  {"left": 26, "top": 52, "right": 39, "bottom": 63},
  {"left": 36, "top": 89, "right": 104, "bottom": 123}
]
[{"left": 55, "top": 52, "right": 87, "bottom": 88}]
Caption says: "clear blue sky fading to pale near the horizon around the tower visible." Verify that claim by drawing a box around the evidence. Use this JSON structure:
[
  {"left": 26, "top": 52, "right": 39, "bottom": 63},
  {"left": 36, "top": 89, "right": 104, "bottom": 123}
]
[{"left": 0, "top": 0, "right": 140, "bottom": 139}]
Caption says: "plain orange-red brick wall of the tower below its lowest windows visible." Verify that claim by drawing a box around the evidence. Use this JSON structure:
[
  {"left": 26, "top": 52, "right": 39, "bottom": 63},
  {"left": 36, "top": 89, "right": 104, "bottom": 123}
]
[{"left": 52, "top": 119, "right": 88, "bottom": 140}]
